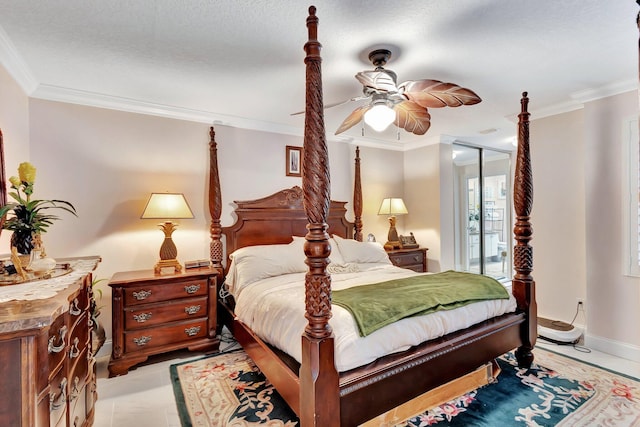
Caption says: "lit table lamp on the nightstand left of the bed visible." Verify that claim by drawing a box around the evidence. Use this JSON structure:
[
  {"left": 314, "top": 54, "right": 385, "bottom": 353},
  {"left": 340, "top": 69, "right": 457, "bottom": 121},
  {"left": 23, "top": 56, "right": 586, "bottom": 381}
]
[{"left": 140, "top": 193, "right": 193, "bottom": 274}]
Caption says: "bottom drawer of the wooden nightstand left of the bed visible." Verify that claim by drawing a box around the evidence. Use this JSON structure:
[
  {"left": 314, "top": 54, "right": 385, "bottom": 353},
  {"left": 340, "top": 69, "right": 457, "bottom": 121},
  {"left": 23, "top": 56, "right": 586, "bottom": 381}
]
[{"left": 124, "top": 319, "right": 207, "bottom": 353}]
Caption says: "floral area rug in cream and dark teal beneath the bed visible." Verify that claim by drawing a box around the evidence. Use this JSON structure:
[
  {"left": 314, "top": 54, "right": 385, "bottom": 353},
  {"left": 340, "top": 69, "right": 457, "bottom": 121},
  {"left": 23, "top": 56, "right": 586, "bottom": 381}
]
[{"left": 170, "top": 349, "right": 640, "bottom": 427}]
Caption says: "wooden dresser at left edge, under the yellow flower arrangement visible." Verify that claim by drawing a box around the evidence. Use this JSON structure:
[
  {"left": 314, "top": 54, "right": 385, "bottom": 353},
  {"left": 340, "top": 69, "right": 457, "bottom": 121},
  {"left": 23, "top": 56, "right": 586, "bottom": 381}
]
[{"left": 0, "top": 257, "right": 100, "bottom": 427}]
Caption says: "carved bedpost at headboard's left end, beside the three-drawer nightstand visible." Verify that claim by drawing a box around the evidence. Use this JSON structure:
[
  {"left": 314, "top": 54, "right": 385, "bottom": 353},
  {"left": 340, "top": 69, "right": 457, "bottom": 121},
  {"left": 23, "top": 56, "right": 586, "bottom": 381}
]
[{"left": 209, "top": 126, "right": 223, "bottom": 272}]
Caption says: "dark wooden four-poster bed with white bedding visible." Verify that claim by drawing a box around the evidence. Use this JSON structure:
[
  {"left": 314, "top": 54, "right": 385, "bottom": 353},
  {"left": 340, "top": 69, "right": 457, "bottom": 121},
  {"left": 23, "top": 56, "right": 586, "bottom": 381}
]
[{"left": 209, "top": 7, "right": 536, "bottom": 427}]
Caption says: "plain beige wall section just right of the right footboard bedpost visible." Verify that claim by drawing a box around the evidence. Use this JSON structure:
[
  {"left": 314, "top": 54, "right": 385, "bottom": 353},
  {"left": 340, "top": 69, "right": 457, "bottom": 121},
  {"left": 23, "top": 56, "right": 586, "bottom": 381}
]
[{"left": 530, "top": 110, "right": 587, "bottom": 326}]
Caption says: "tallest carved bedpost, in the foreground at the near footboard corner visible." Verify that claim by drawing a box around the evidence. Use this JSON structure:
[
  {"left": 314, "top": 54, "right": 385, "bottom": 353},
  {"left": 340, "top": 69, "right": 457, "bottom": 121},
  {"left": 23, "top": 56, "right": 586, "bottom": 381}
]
[{"left": 300, "top": 6, "right": 340, "bottom": 427}]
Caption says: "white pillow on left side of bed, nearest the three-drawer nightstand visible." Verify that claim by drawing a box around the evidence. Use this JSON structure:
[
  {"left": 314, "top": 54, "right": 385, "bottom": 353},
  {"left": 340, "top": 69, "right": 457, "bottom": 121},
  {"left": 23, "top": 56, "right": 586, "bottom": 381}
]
[{"left": 225, "top": 239, "right": 307, "bottom": 297}]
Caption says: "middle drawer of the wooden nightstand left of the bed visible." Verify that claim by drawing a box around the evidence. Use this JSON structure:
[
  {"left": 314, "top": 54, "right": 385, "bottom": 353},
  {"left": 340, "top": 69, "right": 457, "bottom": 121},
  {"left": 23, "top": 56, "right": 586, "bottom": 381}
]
[{"left": 124, "top": 296, "right": 209, "bottom": 330}]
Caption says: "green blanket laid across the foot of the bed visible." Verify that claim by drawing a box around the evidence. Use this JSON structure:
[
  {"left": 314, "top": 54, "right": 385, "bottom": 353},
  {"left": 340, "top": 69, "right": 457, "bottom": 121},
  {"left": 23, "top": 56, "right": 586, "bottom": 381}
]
[{"left": 331, "top": 271, "right": 509, "bottom": 337}]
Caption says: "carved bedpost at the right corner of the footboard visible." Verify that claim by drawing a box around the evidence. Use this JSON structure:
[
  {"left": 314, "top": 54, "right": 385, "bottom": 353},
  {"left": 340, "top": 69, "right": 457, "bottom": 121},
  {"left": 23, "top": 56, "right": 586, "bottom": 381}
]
[{"left": 513, "top": 92, "right": 538, "bottom": 368}]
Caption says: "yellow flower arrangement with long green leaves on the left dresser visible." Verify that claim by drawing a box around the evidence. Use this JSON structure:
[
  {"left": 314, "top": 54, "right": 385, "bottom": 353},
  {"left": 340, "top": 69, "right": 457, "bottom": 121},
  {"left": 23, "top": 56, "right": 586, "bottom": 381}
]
[{"left": 0, "top": 162, "right": 78, "bottom": 255}]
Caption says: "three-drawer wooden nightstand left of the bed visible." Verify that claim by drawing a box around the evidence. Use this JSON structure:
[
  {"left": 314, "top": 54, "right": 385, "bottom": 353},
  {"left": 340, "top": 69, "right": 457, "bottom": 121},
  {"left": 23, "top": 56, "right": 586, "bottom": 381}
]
[{"left": 109, "top": 267, "right": 220, "bottom": 377}]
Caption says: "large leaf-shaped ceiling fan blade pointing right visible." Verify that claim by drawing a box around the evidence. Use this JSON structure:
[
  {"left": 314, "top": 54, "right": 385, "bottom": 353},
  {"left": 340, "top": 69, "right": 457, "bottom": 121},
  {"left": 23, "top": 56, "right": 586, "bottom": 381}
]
[{"left": 399, "top": 79, "right": 482, "bottom": 108}]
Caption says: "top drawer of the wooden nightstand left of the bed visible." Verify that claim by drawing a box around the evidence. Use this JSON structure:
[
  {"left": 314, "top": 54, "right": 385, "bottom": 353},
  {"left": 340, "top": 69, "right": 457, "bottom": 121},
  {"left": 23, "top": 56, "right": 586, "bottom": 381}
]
[{"left": 124, "top": 279, "right": 208, "bottom": 307}]
